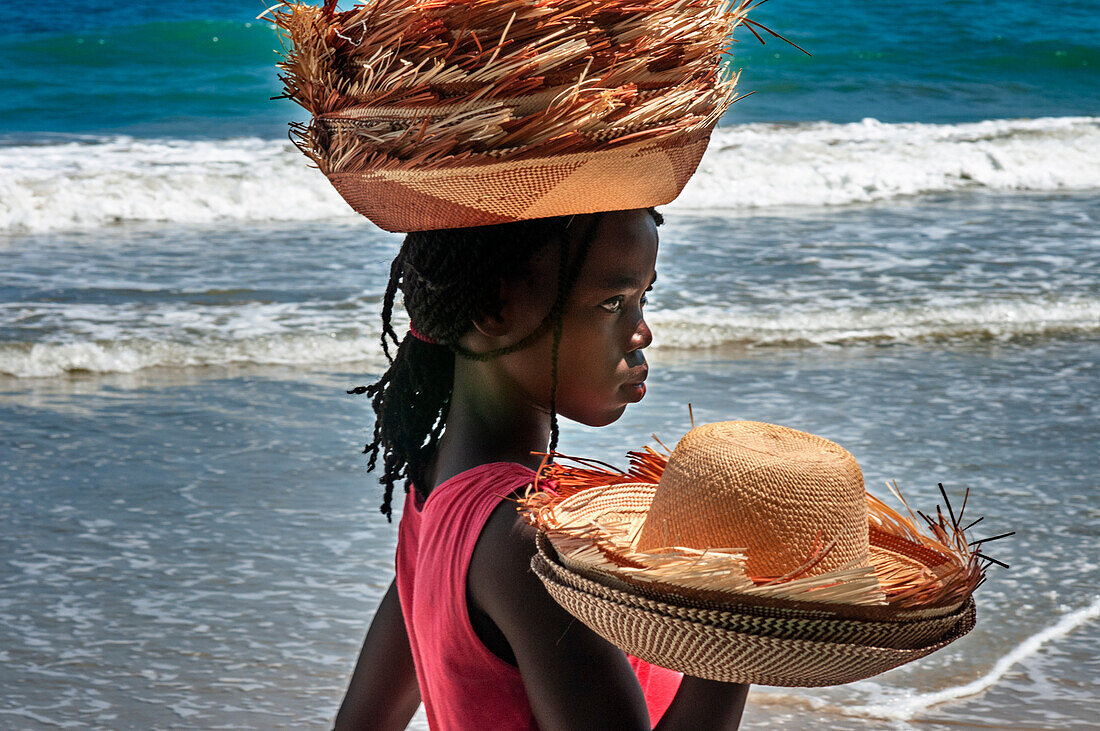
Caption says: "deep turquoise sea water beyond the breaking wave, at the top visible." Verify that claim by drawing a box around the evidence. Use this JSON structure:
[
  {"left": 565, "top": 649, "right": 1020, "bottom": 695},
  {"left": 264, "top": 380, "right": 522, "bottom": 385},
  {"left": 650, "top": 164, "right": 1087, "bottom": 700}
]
[{"left": 0, "top": 0, "right": 1100, "bottom": 137}]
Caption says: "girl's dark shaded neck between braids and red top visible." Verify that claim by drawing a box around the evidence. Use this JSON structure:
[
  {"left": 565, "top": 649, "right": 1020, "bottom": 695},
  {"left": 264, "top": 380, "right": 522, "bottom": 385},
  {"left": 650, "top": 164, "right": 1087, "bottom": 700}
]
[{"left": 429, "top": 357, "right": 550, "bottom": 491}]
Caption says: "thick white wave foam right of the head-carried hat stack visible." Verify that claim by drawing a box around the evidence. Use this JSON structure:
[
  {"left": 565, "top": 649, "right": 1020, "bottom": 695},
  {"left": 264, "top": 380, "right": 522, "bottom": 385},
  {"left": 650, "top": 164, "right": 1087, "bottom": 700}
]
[{"left": 670, "top": 118, "right": 1100, "bottom": 210}]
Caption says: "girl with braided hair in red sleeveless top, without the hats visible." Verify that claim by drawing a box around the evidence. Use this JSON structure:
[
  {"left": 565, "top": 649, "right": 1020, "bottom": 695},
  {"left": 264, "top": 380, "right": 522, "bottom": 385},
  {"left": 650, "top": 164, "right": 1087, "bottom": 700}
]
[{"left": 337, "top": 209, "right": 748, "bottom": 730}]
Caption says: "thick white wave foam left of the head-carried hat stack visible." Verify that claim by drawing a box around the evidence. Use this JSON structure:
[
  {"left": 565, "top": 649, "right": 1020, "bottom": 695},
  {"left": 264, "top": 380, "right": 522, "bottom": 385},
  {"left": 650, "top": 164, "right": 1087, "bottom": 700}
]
[{"left": 0, "top": 137, "right": 353, "bottom": 231}]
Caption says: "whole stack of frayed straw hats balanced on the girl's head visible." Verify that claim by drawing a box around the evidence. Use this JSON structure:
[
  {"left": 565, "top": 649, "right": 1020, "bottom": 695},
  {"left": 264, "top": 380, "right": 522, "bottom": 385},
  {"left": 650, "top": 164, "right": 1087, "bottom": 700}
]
[{"left": 270, "top": 0, "right": 776, "bottom": 232}]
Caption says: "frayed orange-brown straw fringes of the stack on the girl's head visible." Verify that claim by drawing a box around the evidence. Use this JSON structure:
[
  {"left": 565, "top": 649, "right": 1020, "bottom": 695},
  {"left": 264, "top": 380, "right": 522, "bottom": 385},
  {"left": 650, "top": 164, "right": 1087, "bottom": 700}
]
[{"left": 264, "top": 0, "right": 780, "bottom": 174}]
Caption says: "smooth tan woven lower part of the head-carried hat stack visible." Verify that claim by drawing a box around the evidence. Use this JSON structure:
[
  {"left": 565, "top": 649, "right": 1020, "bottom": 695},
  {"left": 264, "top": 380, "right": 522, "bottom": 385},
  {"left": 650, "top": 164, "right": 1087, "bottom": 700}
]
[{"left": 328, "top": 128, "right": 711, "bottom": 232}]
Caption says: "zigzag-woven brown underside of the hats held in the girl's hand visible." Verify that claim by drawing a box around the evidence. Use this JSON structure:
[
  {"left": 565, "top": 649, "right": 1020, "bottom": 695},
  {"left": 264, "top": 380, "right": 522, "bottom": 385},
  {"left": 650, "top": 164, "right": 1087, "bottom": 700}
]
[{"left": 531, "top": 540, "right": 975, "bottom": 687}]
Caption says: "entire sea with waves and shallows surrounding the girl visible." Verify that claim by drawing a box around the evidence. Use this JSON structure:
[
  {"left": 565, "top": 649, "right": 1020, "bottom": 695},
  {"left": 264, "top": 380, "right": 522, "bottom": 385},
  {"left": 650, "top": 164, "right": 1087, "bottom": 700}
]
[{"left": 0, "top": 0, "right": 1100, "bottom": 729}]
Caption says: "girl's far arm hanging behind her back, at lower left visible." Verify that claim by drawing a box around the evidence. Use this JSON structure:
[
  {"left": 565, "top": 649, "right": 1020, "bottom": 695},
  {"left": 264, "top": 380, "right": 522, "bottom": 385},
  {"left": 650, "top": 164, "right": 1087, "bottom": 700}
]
[{"left": 336, "top": 583, "right": 420, "bottom": 730}]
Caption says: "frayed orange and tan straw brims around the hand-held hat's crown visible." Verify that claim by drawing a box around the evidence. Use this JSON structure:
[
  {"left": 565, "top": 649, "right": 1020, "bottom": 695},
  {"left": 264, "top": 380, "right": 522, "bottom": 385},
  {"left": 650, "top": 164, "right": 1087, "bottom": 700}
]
[{"left": 520, "top": 445, "right": 1011, "bottom": 608}]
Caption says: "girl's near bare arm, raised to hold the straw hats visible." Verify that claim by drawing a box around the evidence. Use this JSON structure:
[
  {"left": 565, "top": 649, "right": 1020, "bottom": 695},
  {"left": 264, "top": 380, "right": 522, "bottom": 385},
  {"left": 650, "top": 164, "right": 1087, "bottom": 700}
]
[{"left": 468, "top": 500, "right": 748, "bottom": 731}]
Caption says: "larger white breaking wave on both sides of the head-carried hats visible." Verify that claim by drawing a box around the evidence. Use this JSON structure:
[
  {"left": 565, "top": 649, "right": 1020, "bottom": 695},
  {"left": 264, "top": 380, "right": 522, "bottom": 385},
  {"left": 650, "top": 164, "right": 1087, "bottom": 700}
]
[{"left": 0, "top": 118, "right": 1100, "bottom": 232}]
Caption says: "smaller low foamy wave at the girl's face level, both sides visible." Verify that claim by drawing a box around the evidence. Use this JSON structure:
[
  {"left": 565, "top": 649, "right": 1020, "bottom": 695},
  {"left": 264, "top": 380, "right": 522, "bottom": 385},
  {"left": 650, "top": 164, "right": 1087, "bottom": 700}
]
[{"left": 0, "top": 299, "right": 1100, "bottom": 378}]
